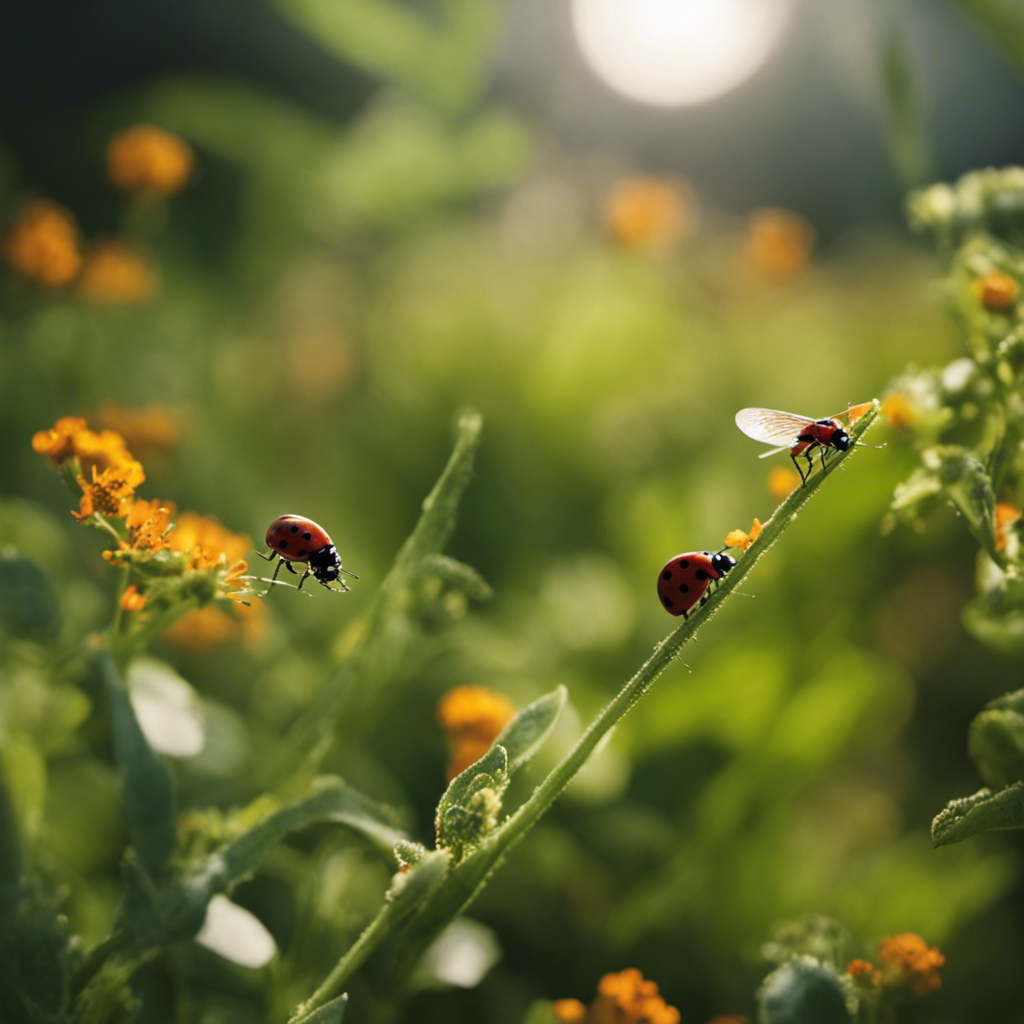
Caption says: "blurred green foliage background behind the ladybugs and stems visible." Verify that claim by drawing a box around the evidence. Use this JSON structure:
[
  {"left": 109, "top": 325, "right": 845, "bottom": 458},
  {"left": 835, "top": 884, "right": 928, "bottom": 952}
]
[{"left": 0, "top": 0, "right": 1024, "bottom": 1024}]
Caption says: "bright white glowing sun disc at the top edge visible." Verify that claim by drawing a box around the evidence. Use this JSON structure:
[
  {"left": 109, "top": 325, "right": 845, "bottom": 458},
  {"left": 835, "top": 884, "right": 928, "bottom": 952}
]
[{"left": 572, "top": 0, "right": 794, "bottom": 106}]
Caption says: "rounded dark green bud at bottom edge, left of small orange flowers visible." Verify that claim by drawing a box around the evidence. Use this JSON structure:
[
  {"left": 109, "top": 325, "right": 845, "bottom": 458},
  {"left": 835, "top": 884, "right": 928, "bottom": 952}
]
[{"left": 758, "top": 956, "right": 857, "bottom": 1024}]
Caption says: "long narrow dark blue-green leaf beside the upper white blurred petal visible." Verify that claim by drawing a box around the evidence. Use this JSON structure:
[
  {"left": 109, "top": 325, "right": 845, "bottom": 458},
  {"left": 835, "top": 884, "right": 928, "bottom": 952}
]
[{"left": 99, "top": 651, "right": 177, "bottom": 878}]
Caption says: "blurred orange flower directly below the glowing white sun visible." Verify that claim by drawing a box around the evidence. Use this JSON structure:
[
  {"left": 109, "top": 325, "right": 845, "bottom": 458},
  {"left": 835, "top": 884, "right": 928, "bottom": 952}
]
[{"left": 603, "top": 177, "right": 695, "bottom": 248}]
